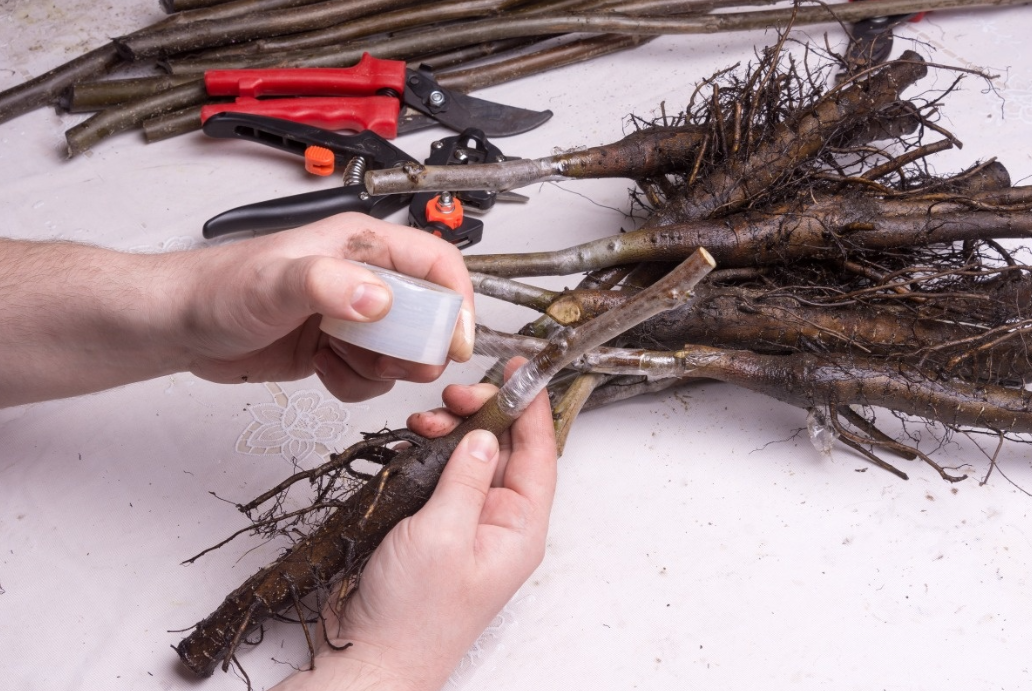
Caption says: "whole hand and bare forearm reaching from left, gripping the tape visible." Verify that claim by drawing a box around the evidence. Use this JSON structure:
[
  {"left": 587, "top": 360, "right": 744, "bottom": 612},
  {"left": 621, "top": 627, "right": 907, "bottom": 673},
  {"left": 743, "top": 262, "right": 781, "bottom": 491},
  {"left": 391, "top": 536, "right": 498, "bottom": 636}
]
[{"left": 0, "top": 213, "right": 474, "bottom": 406}]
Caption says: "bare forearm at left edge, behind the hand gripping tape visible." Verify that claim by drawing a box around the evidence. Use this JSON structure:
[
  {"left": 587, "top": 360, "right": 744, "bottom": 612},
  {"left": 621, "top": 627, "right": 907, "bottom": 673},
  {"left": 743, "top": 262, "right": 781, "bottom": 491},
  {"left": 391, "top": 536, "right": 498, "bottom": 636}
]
[{"left": 0, "top": 239, "right": 185, "bottom": 406}]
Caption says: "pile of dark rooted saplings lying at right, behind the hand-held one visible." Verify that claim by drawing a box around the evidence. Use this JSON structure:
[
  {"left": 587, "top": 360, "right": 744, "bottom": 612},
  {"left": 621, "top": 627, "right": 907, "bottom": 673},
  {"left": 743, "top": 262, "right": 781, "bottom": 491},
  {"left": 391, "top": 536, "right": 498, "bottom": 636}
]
[{"left": 456, "top": 44, "right": 1032, "bottom": 482}]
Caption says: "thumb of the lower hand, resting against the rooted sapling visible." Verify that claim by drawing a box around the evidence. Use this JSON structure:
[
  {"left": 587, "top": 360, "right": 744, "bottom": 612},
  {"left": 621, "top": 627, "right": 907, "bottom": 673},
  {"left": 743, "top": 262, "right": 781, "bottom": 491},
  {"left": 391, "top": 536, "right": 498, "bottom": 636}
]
[{"left": 424, "top": 429, "right": 498, "bottom": 540}]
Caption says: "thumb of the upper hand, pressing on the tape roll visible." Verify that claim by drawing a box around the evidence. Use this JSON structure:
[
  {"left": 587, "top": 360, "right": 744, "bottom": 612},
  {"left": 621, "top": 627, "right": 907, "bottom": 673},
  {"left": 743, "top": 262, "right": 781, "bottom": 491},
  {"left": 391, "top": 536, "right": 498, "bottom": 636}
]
[{"left": 279, "top": 257, "right": 393, "bottom": 322}]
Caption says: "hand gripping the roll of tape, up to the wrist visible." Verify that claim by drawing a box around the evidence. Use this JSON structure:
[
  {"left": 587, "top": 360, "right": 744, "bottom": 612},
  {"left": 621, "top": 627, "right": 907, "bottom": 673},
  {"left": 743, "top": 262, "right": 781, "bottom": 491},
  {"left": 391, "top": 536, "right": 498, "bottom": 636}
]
[{"left": 180, "top": 213, "right": 474, "bottom": 401}]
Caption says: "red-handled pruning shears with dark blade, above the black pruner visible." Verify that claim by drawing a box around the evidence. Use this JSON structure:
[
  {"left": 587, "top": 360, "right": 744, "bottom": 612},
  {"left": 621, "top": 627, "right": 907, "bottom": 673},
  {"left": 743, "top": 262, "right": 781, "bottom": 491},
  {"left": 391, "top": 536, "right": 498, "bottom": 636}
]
[{"left": 201, "top": 53, "right": 552, "bottom": 139}]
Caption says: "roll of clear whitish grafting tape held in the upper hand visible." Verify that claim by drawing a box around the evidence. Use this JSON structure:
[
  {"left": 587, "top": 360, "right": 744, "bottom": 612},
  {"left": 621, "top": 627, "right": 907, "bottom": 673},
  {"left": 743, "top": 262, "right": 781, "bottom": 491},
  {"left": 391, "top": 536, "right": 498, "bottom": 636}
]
[{"left": 319, "top": 262, "right": 462, "bottom": 365}]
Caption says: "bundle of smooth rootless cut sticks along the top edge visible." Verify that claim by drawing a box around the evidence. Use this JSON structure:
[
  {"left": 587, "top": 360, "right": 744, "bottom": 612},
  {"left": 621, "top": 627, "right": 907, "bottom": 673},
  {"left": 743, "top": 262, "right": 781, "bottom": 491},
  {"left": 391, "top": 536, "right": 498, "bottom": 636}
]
[{"left": 0, "top": 0, "right": 1028, "bottom": 157}]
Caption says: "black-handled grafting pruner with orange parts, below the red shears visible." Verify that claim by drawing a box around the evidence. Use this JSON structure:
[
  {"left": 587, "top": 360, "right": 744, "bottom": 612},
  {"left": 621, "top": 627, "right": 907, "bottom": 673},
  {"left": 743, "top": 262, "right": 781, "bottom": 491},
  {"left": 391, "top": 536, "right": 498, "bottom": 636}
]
[{"left": 203, "top": 112, "right": 506, "bottom": 249}]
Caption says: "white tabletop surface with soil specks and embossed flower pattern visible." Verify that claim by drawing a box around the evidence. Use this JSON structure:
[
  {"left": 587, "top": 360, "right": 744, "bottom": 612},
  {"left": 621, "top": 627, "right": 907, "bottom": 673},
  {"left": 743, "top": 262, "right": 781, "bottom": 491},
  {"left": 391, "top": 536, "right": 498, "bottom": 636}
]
[{"left": 0, "top": 5, "right": 1032, "bottom": 691}]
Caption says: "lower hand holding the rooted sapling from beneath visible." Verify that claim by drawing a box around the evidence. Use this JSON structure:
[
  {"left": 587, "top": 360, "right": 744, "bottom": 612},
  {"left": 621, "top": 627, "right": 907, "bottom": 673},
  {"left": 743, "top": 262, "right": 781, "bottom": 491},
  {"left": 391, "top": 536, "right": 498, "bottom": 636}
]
[{"left": 268, "top": 367, "right": 555, "bottom": 691}]
